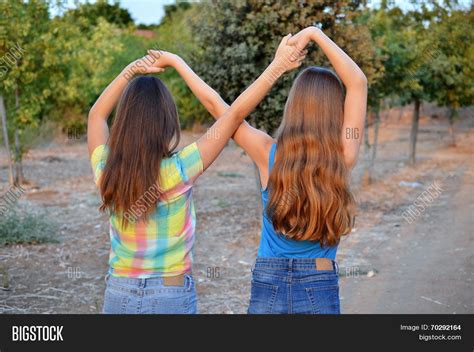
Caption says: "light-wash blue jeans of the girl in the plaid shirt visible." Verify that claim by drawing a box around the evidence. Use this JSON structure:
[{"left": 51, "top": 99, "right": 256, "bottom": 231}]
[{"left": 103, "top": 274, "right": 197, "bottom": 314}]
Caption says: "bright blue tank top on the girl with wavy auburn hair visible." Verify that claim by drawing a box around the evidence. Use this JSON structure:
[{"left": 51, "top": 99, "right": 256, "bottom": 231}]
[{"left": 257, "top": 144, "right": 337, "bottom": 260}]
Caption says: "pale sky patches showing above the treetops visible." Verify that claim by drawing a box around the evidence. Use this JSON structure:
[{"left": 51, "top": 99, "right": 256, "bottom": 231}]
[{"left": 52, "top": 0, "right": 470, "bottom": 24}]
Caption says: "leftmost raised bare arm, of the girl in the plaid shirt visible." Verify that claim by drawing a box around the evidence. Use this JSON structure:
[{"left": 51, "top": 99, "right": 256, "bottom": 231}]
[{"left": 87, "top": 55, "right": 164, "bottom": 156}]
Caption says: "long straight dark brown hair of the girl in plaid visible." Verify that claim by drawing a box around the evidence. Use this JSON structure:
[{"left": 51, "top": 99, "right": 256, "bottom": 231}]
[{"left": 100, "top": 76, "right": 180, "bottom": 225}]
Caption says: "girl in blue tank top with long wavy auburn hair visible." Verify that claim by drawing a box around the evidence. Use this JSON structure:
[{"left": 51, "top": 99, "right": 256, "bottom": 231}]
[{"left": 199, "top": 27, "right": 367, "bottom": 314}]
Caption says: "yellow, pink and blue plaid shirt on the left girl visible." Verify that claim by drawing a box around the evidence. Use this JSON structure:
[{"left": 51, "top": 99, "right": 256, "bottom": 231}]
[{"left": 91, "top": 143, "right": 203, "bottom": 278}]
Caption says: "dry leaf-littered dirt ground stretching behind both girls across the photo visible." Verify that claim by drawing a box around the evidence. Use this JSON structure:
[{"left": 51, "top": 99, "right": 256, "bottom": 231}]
[{"left": 0, "top": 110, "right": 474, "bottom": 313}]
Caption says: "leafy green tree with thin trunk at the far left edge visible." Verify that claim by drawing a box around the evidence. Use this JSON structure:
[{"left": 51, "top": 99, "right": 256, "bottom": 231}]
[{"left": 0, "top": 0, "right": 121, "bottom": 184}]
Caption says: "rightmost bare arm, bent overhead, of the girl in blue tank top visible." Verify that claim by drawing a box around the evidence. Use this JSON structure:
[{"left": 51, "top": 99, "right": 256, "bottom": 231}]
[{"left": 288, "top": 27, "right": 367, "bottom": 168}]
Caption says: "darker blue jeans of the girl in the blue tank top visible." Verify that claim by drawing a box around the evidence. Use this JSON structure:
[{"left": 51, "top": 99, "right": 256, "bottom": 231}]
[{"left": 248, "top": 258, "right": 340, "bottom": 314}]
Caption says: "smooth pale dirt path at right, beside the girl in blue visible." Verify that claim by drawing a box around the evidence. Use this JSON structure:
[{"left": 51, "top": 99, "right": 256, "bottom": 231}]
[{"left": 341, "top": 141, "right": 474, "bottom": 313}]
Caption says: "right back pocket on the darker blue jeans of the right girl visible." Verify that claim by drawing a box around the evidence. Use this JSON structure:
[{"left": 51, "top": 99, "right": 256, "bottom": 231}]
[{"left": 305, "top": 285, "right": 341, "bottom": 314}]
